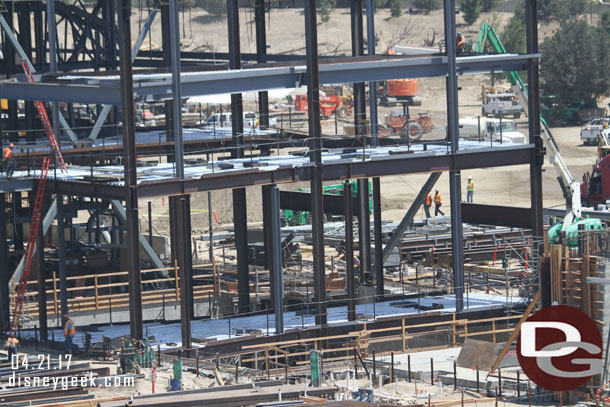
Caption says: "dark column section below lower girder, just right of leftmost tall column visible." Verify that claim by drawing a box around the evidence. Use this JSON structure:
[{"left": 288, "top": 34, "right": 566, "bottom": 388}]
[{"left": 170, "top": 194, "right": 193, "bottom": 349}]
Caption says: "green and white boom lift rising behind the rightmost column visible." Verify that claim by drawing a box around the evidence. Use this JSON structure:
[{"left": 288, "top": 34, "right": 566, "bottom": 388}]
[{"left": 472, "top": 23, "right": 610, "bottom": 245}]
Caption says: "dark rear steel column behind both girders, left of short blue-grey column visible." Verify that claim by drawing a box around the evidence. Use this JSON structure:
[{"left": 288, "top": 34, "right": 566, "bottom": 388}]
[{"left": 227, "top": 0, "right": 250, "bottom": 312}]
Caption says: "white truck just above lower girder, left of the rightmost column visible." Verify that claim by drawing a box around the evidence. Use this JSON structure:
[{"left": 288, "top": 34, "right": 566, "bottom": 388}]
[{"left": 460, "top": 116, "right": 527, "bottom": 144}]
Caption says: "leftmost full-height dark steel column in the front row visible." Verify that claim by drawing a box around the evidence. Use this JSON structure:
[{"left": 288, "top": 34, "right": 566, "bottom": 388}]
[{"left": 119, "top": 0, "right": 144, "bottom": 340}]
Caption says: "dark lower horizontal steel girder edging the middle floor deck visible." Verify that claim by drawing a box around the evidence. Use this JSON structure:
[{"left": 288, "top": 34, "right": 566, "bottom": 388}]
[{"left": 47, "top": 144, "right": 534, "bottom": 199}]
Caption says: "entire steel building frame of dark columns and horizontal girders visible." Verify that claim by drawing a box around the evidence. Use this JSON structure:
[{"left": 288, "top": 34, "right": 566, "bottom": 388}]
[{"left": 0, "top": 0, "right": 545, "bottom": 347}]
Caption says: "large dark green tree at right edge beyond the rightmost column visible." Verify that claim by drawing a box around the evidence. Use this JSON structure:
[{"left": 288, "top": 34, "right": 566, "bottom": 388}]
[{"left": 541, "top": 20, "right": 610, "bottom": 106}]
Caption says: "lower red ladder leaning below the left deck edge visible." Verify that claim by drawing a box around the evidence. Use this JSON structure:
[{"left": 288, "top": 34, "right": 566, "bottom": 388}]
[{"left": 9, "top": 157, "right": 51, "bottom": 338}]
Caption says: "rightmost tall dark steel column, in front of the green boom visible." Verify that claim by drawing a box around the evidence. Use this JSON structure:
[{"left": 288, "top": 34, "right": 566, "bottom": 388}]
[{"left": 525, "top": 0, "right": 540, "bottom": 307}]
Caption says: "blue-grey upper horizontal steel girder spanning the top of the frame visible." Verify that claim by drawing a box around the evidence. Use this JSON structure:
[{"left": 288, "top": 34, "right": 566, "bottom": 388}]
[{"left": 0, "top": 54, "right": 541, "bottom": 105}]
